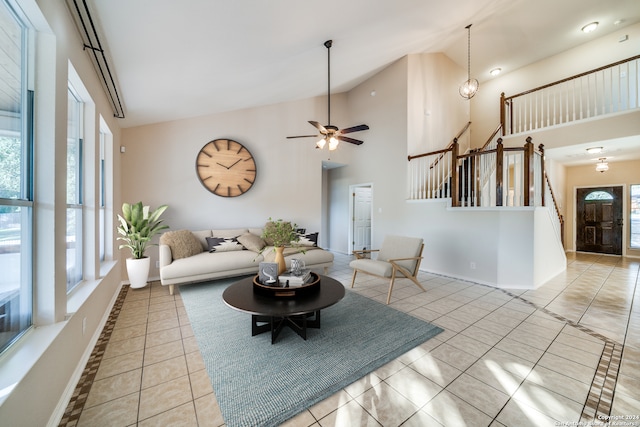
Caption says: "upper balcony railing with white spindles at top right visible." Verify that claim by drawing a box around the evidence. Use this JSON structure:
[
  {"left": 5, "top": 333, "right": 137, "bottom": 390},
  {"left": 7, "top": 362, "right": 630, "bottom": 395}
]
[{"left": 500, "top": 55, "right": 640, "bottom": 136}]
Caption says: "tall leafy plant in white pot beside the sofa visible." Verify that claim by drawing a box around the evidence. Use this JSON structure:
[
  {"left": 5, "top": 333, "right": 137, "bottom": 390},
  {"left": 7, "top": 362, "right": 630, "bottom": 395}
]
[{"left": 117, "top": 202, "right": 169, "bottom": 288}]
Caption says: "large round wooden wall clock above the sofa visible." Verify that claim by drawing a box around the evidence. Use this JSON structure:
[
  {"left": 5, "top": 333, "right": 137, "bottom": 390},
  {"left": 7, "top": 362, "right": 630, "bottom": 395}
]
[{"left": 196, "top": 139, "right": 256, "bottom": 197}]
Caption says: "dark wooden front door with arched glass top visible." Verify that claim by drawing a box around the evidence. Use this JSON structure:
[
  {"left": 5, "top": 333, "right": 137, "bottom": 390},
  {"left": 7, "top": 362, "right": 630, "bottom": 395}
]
[{"left": 576, "top": 187, "right": 622, "bottom": 255}]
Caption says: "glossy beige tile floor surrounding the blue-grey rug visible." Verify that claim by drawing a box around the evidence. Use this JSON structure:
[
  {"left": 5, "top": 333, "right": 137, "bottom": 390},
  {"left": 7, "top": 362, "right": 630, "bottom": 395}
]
[{"left": 60, "top": 254, "right": 640, "bottom": 427}]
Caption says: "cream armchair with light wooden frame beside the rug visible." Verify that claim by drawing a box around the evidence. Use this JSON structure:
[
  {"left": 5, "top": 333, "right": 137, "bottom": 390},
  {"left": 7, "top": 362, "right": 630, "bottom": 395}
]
[{"left": 349, "top": 236, "right": 425, "bottom": 304}]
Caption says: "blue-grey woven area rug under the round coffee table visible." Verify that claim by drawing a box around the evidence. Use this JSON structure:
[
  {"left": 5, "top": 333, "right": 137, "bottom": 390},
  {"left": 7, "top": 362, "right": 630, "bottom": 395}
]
[{"left": 180, "top": 278, "right": 442, "bottom": 427}]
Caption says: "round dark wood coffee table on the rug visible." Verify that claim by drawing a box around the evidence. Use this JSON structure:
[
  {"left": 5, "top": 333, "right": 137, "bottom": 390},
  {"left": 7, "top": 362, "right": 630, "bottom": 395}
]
[{"left": 222, "top": 276, "right": 344, "bottom": 344}]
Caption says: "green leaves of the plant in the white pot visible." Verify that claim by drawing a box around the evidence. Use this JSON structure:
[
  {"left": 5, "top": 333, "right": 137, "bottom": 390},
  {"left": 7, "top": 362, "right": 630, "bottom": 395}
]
[{"left": 118, "top": 202, "right": 169, "bottom": 259}]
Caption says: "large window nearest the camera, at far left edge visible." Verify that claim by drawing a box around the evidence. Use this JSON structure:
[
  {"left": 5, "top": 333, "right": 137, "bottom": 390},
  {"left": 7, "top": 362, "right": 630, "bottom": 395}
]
[{"left": 0, "top": 0, "right": 33, "bottom": 351}]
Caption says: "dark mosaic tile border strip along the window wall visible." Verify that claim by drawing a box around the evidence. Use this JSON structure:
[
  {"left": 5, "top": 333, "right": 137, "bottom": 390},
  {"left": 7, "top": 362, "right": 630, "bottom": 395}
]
[{"left": 58, "top": 286, "right": 129, "bottom": 427}]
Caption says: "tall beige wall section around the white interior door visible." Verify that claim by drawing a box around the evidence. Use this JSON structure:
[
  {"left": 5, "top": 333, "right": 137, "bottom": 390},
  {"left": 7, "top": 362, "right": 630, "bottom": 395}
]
[{"left": 328, "top": 57, "right": 408, "bottom": 253}]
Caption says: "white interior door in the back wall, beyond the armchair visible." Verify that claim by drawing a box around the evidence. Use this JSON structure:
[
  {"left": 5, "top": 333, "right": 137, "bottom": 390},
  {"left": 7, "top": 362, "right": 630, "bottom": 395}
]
[{"left": 349, "top": 184, "right": 373, "bottom": 251}]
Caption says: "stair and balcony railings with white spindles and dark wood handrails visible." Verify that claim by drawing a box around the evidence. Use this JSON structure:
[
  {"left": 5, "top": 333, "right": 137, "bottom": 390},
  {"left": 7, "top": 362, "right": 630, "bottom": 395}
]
[{"left": 408, "top": 55, "right": 640, "bottom": 247}]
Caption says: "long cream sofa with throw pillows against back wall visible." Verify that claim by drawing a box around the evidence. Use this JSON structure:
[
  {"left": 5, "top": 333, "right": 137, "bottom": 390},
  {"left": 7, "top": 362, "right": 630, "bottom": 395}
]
[{"left": 159, "top": 228, "right": 333, "bottom": 295}]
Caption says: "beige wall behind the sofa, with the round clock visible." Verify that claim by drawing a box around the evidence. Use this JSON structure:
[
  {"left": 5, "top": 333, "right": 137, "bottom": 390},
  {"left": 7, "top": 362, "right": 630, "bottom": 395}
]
[{"left": 120, "top": 94, "right": 349, "bottom": 278}]
